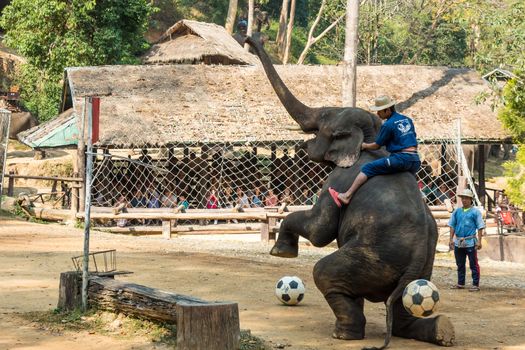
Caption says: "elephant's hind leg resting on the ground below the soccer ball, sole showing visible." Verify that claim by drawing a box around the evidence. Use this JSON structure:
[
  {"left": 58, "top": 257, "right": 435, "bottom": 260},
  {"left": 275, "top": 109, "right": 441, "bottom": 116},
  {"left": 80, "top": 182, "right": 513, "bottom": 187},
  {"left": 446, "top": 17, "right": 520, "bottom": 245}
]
[{"left": 392, "top": 299, "right": 455, "bottom": 346}]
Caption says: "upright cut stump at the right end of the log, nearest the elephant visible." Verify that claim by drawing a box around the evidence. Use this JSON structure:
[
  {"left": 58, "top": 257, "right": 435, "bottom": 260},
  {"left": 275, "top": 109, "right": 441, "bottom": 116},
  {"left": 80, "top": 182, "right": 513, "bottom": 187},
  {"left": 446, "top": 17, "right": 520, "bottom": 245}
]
[{"left": 176, "top": 302, "right": 241, "bottom": 350}]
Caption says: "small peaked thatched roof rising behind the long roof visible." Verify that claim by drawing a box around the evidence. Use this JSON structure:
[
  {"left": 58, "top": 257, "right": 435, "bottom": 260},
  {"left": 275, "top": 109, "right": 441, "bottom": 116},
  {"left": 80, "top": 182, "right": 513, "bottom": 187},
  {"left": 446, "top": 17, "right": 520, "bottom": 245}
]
[{"left": 142, "top": 20, "right": 258, "bottom": 65}]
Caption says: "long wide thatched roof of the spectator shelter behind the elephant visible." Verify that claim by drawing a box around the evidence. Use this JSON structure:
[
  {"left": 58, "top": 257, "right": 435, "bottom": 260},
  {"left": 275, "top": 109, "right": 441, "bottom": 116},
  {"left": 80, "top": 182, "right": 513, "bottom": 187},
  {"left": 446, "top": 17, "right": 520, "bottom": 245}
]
[{"left": 17, "top": 65, "right": 510, "bottom": 147}]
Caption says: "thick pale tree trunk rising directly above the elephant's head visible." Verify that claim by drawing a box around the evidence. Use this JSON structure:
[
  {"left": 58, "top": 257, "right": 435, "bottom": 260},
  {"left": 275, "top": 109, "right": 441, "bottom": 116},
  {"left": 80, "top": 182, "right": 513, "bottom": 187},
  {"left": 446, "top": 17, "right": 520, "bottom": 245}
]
[{"left": 343, "top": 0, "right": 359, "bottom": 107}]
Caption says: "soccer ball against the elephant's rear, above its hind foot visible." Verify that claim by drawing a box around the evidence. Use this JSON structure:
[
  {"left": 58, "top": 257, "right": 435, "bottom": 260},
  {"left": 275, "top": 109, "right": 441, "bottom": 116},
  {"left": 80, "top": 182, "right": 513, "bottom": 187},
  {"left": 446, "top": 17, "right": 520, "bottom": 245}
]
[{"left": 403, "top": 279, "right": 439, "bottom": 317}]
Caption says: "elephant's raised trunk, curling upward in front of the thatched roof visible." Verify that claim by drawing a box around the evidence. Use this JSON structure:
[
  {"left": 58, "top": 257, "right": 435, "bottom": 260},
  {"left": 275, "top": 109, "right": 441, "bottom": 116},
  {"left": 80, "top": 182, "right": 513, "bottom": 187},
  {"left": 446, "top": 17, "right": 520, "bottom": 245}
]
[{"left": 246, "top": 37, "right": 319, "bottom": 132}]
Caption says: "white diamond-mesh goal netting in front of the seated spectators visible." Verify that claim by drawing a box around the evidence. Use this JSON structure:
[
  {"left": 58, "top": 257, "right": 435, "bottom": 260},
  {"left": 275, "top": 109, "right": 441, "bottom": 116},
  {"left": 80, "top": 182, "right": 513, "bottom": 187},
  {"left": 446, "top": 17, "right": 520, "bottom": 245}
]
[{"left": 87, "top": 117, "right": 474, "bottom": 221}]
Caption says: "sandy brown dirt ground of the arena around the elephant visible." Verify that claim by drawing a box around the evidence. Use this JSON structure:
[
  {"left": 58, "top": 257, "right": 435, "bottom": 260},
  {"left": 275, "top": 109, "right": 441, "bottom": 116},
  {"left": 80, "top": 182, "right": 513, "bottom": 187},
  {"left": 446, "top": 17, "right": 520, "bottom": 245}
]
[{"left": 0, "top": 216, "right": 525, "bottom": 350}]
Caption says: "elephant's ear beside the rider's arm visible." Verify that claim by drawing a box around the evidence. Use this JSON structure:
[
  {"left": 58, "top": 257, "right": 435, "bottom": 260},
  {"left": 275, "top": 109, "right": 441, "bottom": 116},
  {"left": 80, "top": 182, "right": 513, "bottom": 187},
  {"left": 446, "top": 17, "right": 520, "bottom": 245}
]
[{"left": 324, "top": 126, "right": 364, "bottom": 168}]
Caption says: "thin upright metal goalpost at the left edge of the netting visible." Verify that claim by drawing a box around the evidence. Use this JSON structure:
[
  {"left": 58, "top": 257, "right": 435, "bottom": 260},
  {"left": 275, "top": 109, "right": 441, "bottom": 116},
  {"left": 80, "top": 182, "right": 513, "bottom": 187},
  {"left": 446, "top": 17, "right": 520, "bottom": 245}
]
[{"left": 82, "top": 97, "right": 93, "bottom": 311}]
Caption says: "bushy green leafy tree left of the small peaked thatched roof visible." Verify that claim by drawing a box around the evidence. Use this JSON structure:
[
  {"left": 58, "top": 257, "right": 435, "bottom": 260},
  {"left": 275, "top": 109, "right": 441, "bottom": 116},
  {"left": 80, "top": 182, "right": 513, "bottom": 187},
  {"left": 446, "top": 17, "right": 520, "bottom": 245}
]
[{"left": 0, "top": 0, "right": 154, "bottom": 121}]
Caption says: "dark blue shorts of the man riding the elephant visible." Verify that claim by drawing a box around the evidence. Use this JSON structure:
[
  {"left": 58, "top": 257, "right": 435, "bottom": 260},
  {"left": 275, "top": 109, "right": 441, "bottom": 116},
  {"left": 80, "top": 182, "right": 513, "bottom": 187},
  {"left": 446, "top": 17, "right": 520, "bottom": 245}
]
[{"left": 361, "top": 152, "right": 421, "bottom": 178}]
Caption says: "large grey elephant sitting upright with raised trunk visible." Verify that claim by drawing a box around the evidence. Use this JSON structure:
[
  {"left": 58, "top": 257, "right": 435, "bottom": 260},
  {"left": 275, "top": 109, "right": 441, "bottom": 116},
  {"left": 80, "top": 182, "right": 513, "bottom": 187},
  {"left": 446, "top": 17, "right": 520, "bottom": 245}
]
[{"left": 246, "top": 37, "right": 455, "bottom": 349}]
